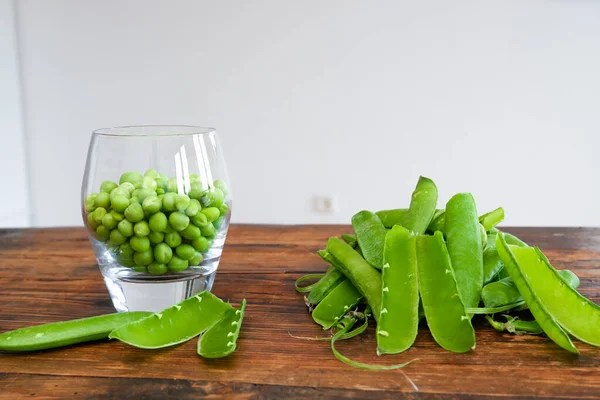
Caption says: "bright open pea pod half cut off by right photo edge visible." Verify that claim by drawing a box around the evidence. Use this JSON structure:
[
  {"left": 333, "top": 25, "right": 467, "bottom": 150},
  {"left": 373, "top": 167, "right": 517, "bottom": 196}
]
[{"left": 509, "top": 247, "right": 600, "bottom": 346}]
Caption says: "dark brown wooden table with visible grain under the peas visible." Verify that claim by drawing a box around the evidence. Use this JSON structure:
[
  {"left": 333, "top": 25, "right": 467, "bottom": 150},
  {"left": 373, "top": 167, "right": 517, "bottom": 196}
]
[{"left": 0, "top": 225, "right": 600, "bottom": 399}]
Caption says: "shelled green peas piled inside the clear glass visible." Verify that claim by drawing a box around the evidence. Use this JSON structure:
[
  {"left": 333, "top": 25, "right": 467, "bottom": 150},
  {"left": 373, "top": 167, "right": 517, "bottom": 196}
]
[{"left": 85, "top": 169, "right": 228, "bottom": 275}]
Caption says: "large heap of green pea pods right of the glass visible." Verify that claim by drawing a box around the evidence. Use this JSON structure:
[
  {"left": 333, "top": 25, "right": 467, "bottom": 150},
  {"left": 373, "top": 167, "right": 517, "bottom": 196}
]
[{"left": 296, "top": 177, "right": 600, "bottom": 369}]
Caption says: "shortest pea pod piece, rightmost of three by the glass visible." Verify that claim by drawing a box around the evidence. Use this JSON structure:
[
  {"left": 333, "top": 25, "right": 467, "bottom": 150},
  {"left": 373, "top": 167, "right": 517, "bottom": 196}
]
[{"left": 198, "top": 299, "right": 246, "bottom": 358}]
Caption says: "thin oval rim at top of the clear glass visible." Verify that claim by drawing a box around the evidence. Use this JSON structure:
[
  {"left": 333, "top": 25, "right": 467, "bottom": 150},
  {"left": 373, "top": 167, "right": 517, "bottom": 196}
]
[{"left": 92, "top": 125, "right": 217, "bottom": 137}]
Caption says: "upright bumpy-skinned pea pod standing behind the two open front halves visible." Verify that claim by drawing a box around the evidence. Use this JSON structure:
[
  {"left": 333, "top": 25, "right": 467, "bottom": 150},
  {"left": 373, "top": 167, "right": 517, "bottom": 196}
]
[{"left": 446, "top": 193, "right": 483, "bottom": 308}]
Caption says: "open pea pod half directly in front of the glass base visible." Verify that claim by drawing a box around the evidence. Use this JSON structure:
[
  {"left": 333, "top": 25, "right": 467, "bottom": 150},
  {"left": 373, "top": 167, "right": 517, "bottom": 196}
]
[{"left": 109, "top": 291, "right": 232, "bottom": 349}]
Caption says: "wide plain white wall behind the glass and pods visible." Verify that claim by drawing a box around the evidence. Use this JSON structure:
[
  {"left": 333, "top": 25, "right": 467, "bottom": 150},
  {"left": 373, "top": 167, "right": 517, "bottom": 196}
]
[{"left": 10, "top": 0, "right": 600, "bottom": 225}]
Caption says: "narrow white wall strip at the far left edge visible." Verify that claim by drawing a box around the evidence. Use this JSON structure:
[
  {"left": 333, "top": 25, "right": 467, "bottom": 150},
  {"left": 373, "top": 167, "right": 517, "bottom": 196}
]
[{"left": 0, "top": 0, "right": 30, "bottom": 227}]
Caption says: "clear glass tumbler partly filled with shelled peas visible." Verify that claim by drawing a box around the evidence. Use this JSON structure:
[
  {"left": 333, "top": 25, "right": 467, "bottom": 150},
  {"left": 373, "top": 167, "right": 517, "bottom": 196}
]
[{"left": 81, "top": 126, "right": 231, "bottom": 311}]
